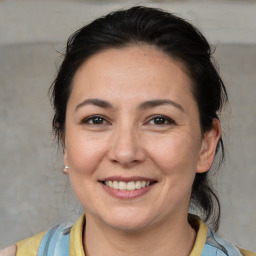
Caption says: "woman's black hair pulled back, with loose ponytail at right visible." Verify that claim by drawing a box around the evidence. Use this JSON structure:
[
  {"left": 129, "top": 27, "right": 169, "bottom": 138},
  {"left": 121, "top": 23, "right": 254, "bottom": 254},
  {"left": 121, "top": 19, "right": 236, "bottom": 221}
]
[{"left": 50, "top": 6, "right": 228, "bottom": 230}]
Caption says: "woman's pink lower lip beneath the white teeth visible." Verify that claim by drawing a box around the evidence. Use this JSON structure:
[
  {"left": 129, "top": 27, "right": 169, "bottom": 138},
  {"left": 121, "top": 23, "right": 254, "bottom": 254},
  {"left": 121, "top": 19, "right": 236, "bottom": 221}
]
[{"left": 101, "top": 183, "right": 155, "bottom": 199}]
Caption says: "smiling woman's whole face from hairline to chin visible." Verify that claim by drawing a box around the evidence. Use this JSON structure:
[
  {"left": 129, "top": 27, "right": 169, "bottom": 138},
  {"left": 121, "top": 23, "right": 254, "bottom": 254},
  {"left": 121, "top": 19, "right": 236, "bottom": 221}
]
[{"left": 64, "top": 46, "right": 217, "bottom": 230}]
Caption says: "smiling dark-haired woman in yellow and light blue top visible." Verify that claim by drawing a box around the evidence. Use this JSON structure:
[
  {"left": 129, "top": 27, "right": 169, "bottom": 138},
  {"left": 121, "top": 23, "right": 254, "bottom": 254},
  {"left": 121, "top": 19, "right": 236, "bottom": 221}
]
[{"left": 1, "top": 7, "right": 256, "bottom": 256}]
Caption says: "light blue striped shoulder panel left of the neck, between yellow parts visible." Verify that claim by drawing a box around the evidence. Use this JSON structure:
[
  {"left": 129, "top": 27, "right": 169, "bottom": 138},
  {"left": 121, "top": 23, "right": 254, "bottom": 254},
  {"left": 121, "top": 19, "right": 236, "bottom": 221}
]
[{"left": 37, "top": 224, "right": 71, "bottom": 256}]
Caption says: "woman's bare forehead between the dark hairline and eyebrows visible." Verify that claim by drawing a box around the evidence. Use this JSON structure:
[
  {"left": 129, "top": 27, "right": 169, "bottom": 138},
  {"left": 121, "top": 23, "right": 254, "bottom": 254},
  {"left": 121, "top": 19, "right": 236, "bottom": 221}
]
[{"left": 71, "top": 45, "right": 195, "bottom": 107}]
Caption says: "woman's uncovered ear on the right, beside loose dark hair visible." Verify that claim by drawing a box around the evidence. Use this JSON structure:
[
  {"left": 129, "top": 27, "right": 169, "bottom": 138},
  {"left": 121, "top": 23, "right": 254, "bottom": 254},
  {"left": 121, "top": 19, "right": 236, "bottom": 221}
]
[{"left": 196, "top": 118, "right": 221, "bottom": 173}]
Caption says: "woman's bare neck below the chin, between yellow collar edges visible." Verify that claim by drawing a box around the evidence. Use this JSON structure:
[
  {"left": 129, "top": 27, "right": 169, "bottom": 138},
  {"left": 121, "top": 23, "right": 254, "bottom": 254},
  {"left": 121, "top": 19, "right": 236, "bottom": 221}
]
[{"left": 84, "top": 216, "right": 196, "bottom": 256}]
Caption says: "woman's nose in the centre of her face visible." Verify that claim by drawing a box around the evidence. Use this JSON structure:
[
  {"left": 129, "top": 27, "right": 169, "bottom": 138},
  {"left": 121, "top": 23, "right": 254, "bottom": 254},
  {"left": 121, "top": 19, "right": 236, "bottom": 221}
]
[{"left": 108, "top": 124, "right": 146, "bottom": 168}]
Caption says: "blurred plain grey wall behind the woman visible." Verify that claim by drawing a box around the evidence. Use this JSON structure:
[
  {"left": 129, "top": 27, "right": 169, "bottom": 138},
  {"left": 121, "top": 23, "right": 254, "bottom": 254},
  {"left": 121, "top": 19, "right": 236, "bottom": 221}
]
[{"left": 0, "top": 0, "right": 256, "bottom": 250}]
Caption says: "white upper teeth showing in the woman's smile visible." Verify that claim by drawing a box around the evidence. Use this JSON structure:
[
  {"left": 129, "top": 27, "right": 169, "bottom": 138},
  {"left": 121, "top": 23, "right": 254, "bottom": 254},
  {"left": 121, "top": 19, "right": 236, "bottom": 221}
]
[{"left": 104, "top": 180, "right": 150, "bottom": 191}]
